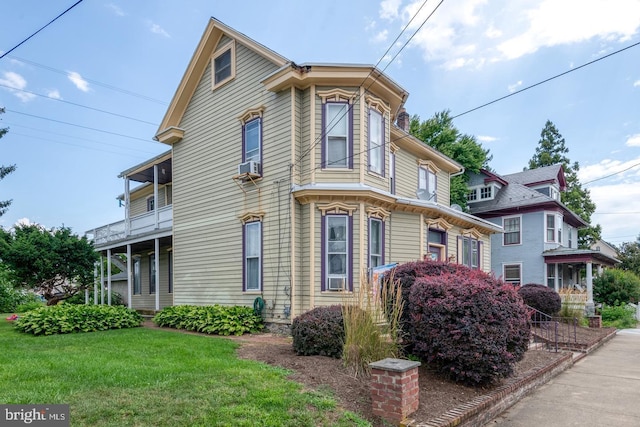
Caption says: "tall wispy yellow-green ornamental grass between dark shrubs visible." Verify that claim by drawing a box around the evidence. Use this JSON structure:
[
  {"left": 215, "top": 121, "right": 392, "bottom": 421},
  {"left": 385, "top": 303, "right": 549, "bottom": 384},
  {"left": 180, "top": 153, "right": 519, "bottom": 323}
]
[{"left": 342, "top": 277, "right": 402, "bottom": 376}]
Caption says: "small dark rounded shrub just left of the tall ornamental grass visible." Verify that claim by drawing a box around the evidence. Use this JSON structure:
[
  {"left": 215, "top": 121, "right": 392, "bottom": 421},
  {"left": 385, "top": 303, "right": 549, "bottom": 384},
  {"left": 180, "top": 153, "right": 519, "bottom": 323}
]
[{"left": 291, "top": 305, "right": 344, "bottom": 359}]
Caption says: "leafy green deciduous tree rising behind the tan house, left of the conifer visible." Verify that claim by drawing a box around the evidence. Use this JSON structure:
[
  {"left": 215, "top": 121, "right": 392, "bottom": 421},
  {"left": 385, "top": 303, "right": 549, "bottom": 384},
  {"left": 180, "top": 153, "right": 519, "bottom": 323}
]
[{"left": 409, "top": 110, "right": 492, "bottom": 210}]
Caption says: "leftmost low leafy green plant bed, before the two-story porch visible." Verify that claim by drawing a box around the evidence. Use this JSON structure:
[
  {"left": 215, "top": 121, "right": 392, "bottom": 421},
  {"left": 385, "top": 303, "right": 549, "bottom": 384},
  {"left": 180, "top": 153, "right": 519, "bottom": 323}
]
[{"left": 15, "top": 303, "right": 142, "bottom": 335}]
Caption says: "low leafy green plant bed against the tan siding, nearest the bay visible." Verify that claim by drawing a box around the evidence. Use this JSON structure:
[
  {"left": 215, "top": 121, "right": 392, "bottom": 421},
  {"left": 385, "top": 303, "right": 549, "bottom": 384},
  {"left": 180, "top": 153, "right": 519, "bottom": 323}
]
[{"left": 153, "top": 304, "right": 264, "bottom": 335}]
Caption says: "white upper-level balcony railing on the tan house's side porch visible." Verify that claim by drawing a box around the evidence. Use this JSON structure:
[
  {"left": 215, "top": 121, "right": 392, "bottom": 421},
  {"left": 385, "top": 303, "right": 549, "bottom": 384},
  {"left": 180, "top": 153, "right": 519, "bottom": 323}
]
[{"left": 87, "top": 205, "right": 173, "bottom": 245}]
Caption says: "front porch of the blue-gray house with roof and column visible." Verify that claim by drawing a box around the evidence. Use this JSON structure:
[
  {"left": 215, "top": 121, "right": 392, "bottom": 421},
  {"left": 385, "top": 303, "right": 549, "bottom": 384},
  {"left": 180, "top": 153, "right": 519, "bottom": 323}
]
[{"left": 542, "top": 247, "right": 620, "bottom": 315}]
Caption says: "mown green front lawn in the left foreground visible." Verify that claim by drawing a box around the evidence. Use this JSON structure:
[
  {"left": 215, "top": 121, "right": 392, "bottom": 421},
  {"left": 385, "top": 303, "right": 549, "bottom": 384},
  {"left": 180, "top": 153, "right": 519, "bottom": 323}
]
[{"left": 0, "top": 315, "right": 369, "bottom": 426}]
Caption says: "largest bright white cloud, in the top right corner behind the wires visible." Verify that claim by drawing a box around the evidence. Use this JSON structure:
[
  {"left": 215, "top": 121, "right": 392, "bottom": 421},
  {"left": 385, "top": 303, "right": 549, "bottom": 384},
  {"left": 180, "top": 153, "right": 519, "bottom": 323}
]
[{"left": 379, "top": 0, "right": 640, "bottom": 69}]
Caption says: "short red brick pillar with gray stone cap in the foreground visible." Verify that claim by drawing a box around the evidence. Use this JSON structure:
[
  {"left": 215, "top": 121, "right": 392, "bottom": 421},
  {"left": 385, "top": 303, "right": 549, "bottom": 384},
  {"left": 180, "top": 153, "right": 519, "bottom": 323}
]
[{"left": 369, "top": 359, "right": 420, "bottom": 423}]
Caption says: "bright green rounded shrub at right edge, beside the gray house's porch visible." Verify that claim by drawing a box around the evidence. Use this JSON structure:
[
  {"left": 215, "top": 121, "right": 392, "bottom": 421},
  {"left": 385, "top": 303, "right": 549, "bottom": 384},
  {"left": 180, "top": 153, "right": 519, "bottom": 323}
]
[{"left": 593, "top": 268, "right": 640, "bottom": 305}]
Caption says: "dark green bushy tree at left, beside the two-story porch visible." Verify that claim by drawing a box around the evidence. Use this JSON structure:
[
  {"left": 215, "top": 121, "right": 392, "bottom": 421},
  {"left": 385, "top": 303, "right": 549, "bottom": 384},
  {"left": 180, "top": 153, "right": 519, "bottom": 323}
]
[{"left": 0, "top": 224, "right": 99, "bottom": 305}]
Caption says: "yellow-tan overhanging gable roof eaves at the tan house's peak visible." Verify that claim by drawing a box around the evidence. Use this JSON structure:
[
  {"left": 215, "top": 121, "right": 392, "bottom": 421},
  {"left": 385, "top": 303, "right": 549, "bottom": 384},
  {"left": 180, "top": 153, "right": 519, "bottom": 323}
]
[{"left": 154, "top": 17, "right": 291, "bottom": 139}]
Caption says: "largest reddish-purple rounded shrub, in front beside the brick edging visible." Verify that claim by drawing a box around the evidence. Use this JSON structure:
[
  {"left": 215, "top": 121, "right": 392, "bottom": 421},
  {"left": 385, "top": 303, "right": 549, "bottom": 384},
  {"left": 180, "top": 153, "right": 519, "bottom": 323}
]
[{"left": 409, "top": 273, "right": 530, "bottom": 385}]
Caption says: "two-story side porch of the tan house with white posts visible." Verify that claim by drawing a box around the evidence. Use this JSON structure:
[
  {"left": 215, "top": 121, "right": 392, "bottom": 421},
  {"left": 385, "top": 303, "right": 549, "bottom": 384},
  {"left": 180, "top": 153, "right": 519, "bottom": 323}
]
[{"left": 85, "top": 151, "right": 173, "bottom": 312}]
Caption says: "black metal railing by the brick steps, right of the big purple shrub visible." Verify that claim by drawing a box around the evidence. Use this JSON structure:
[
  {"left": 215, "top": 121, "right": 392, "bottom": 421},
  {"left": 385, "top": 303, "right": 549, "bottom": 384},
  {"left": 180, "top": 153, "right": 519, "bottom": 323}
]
[{"left": 528, "top": 307, "right": 578, "bottom": 352}]
